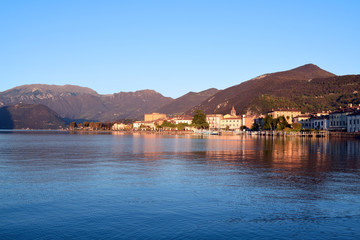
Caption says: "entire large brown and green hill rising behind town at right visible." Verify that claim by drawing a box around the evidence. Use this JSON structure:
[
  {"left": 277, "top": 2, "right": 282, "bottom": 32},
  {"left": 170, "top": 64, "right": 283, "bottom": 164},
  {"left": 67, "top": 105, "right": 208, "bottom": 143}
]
[{"left": 188, "top": 64, "right": 360, "bottom": 114}]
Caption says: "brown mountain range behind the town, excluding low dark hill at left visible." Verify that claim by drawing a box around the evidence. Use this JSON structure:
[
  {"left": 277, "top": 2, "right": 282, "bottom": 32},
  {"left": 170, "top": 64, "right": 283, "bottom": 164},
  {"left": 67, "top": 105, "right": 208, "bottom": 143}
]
[{"left": 0, "top": 64, "right": 360, "bottom": 129}]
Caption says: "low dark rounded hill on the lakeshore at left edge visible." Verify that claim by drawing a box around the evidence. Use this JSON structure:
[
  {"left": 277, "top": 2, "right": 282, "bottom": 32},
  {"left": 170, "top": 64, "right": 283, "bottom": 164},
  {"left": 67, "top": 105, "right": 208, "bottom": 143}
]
[{"left": 0, "top": 104, "right": 67, "bottom": 129}]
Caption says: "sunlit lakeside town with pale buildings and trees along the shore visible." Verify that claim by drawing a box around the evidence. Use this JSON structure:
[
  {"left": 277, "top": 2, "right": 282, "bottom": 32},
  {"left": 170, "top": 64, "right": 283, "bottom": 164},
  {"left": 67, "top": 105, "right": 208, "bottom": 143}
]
[{"left": 69, "top": 104, "right": 360, "bottom": 137}]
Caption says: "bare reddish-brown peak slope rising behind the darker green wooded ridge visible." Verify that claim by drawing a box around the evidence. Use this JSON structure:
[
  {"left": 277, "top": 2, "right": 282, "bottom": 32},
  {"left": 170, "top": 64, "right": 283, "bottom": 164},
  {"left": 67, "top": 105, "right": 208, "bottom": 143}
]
[{"left": 188, "top": 64, "right": 335, "bottom": 113}]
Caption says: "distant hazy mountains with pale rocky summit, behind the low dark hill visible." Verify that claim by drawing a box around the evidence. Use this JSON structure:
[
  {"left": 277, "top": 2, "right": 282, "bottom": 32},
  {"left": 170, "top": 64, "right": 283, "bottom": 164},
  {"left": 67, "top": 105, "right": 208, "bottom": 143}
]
[{"left": 0, "top": 84, "right": 173, "bottom": 121}]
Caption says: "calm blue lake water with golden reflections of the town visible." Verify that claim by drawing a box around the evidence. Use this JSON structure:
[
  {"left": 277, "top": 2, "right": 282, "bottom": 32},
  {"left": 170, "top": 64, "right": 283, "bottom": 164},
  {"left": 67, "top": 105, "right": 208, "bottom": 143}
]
[{"left": 0, "top": 131, "right": 360, "bottom": 239}]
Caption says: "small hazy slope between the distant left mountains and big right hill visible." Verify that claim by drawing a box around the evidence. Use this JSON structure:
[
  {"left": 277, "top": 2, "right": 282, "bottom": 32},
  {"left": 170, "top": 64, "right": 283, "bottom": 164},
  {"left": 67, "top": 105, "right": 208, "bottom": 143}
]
[{"left": 156, "top": 88, "right": 219, "bottom": 114}]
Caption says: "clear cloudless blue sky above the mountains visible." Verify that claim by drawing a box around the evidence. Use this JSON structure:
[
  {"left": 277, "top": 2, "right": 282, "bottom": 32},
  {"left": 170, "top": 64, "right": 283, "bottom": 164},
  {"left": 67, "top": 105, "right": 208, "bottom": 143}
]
[{"left": 0, "top": 0, "right": 360, "bottom": 98}]
